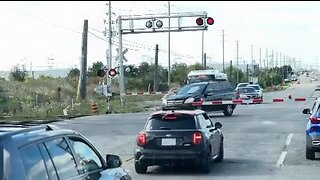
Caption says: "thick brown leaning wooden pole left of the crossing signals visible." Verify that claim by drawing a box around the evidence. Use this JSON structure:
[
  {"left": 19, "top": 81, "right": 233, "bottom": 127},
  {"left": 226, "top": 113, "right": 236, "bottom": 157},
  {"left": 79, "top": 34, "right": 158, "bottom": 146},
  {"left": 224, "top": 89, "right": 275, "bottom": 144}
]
[{"left": 77, "top": 19, "right": 88, "bottom": 100}]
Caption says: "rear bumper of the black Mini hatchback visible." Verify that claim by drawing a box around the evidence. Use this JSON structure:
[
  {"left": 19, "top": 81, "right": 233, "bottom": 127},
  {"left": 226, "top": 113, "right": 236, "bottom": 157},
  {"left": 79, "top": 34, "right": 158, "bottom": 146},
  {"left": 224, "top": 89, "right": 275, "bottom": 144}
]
[{"left": 135, "top": 148, "right": 206, "bottom": 166}]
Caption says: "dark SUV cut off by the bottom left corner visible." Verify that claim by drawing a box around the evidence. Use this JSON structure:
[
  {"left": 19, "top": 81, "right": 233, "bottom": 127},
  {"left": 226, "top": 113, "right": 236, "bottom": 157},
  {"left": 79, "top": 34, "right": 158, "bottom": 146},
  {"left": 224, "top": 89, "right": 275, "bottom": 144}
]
[{"left": 0, "top": 125, "right": 131, "bottom": 180}]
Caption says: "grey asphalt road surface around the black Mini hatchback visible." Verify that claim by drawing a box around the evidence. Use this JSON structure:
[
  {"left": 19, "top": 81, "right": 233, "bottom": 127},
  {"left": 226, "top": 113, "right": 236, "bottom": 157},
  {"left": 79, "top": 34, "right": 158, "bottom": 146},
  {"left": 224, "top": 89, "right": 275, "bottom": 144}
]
[{"left": 51, "top": 77, "right": 320, "bottom": 180}]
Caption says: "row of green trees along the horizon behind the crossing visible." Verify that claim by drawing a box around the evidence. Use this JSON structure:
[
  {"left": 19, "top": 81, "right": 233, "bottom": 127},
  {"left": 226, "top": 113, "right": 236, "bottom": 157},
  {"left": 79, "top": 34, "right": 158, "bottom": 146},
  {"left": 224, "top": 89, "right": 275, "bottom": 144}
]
[{"left": 9, "top": 61, "right": 293, "bottom": 91}]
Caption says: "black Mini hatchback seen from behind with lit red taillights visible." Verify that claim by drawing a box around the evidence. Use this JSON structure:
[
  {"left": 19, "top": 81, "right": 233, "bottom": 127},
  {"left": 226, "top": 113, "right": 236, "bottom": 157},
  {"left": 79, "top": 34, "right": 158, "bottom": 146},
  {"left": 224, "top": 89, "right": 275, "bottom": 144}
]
[{"left": 134, "top": 107, "right": 224, "bottom": 173}]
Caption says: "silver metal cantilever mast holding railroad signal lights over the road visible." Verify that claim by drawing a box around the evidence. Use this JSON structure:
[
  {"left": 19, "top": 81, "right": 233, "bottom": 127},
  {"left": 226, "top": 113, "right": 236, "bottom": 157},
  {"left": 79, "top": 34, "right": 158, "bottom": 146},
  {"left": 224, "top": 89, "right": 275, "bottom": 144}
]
[{"left": 117, "top": 11, "right": 214, "bottom": 107}]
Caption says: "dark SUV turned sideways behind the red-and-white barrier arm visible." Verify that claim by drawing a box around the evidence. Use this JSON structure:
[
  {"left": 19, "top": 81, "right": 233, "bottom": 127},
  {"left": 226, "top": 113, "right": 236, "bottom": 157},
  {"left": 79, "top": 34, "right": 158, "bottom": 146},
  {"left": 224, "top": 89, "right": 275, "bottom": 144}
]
[{"left": 163, "top": 81, "right": 238, "bottom": 116}]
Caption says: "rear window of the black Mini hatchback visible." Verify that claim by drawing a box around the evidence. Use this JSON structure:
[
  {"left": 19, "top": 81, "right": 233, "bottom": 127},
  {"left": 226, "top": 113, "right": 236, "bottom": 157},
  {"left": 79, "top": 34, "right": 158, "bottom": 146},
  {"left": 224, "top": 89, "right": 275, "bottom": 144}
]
[{"left": 146, "top": 115, "right": 196, "bottom": 130}]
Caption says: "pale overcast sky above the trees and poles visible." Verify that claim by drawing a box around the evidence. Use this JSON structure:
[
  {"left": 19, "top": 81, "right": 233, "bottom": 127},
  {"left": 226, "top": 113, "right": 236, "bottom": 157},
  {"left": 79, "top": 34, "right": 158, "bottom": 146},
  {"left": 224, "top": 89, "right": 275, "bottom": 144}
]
[{"left": 0, "top": 1, "right": 320, "bottom": 71}]
